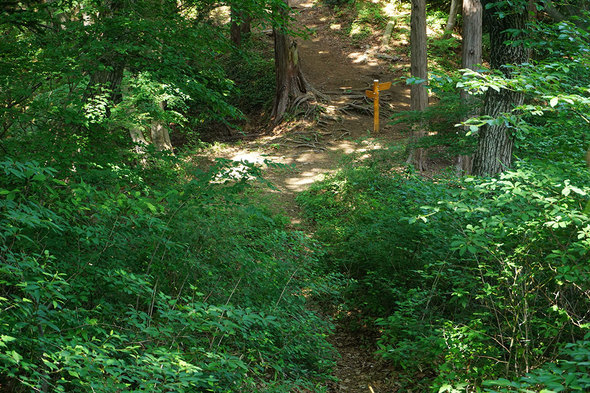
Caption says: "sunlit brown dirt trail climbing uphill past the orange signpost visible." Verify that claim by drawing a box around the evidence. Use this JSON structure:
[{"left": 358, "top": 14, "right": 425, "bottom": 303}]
[{"left": 215, "top": 0, "right": 409, "bottom": 226}]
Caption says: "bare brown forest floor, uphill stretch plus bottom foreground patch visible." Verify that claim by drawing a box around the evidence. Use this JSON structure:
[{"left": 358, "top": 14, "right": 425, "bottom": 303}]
[{"left": 206, "top": 0, "right": 418, "bottom": 393}]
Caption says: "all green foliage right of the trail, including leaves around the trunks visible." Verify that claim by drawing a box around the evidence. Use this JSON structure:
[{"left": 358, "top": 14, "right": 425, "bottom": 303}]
[{"left": 306, "top": 2, "right": 590, "bottom": 392}]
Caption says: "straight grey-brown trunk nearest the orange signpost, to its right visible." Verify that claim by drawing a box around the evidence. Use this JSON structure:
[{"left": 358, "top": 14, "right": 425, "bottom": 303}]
[{"left": 408, "top": 0, "right": 428, "bottom": 171}]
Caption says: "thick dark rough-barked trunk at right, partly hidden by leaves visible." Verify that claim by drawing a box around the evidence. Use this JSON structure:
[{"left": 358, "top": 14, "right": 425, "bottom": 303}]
[{"left": 473, "top": 6, "right": 529, "bottom": 175}]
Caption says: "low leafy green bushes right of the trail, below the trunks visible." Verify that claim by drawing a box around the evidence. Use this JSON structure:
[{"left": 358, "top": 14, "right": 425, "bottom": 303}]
[{"left": 301, "top": 150, "right": 590, "bottom": 387}]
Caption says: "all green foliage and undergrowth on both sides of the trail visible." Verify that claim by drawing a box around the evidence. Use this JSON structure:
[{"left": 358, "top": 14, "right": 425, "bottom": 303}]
[{"left": 0, "top": 0, "right": 590, "bottom": 393}]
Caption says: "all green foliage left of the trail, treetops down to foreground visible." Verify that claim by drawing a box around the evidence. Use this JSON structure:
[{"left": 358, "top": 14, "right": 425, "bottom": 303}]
[{"left": 0, "top": 0, "right": 340, "bottom": 392}]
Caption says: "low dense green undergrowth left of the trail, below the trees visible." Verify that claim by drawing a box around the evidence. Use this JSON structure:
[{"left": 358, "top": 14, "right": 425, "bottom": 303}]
[{"left": 0, "top": 152, "right": 332, "bottom": 392}]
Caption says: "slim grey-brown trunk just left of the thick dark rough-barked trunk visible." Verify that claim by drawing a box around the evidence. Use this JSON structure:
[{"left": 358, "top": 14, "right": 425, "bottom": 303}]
[{"left": 457, "top": 0, "right": 483, "bottom": 174}]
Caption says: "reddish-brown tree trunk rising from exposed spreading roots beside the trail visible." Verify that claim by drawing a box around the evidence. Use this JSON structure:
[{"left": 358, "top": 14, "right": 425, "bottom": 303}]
[{"left": 271, "top": 1, "right": 310, "bottom": 125}]
